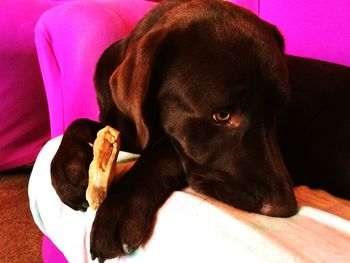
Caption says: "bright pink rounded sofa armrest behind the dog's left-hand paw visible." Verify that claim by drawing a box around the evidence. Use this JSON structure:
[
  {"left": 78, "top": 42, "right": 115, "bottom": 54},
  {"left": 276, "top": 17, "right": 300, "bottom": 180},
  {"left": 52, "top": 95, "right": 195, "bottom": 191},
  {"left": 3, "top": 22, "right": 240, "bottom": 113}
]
[{"left": 35, "top": 1, "right": 154, "bottom": 137}]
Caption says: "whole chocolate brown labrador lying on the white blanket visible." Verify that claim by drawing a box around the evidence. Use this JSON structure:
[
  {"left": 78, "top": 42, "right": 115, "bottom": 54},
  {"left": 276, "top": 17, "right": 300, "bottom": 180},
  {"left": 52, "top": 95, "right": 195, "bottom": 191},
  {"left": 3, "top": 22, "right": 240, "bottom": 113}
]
[{"left": 51, "top": 0, "right": 350, "bottom": 261}]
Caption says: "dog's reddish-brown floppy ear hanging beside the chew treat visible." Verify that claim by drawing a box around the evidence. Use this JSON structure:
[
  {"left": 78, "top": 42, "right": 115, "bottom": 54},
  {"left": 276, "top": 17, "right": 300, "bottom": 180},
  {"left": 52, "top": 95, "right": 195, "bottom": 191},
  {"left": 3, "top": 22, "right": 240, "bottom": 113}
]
[{"left": 109, "top": 28, "right": 167, "bottom": 150}]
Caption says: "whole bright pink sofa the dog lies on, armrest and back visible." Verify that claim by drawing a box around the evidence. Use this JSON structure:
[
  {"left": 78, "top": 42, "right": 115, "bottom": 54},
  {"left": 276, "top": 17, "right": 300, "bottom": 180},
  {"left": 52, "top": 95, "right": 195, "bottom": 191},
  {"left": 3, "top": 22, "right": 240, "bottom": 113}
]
[{"left": 35, "top": 0, "right": 350, "bottom": 262}]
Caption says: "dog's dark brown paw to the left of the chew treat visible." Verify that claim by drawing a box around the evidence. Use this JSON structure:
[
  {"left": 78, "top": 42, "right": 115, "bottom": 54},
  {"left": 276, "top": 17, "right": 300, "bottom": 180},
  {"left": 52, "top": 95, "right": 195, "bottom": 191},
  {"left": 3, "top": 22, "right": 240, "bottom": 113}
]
[{"left": 51, "top": 119, "right": 103, "bottom": 211}]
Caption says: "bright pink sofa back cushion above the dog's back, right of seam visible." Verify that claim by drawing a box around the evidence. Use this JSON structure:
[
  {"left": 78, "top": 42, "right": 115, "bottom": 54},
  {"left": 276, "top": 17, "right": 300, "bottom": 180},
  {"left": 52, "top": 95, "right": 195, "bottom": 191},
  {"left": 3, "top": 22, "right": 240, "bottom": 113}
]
[{"left": 260, "top": 0, "right": 350, "bottom": 66}]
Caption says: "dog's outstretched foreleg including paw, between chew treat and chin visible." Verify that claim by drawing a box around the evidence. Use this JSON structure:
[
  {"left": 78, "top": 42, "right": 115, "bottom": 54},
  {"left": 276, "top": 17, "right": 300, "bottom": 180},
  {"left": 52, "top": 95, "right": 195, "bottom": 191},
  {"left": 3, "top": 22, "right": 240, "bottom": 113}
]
[{"left": 91, "top": 139, "right": 186, "bottom": 261}]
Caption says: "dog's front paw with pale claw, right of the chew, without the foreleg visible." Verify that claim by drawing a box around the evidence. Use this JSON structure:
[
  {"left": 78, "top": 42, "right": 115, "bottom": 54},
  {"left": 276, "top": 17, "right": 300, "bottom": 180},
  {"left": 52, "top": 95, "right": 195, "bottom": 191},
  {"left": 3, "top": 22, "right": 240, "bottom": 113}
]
[{"left": 90, "top": 189, "right": 156, "bottom": 262}]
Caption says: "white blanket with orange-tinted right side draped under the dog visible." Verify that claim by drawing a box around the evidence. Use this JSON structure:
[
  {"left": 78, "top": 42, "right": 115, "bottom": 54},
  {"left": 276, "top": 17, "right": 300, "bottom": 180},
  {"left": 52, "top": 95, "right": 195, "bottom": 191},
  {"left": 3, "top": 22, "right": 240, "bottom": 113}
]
[{"left": 29, "top": 137, "right": 350, "bottom": 263}]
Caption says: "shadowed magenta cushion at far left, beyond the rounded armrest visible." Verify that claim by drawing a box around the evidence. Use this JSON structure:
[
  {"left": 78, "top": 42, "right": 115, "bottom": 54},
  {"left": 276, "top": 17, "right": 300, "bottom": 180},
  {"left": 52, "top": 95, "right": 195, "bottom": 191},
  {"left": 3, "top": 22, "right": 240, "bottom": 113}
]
[{"left": 0, "top": 0, "right": 69, "bottom": 171}]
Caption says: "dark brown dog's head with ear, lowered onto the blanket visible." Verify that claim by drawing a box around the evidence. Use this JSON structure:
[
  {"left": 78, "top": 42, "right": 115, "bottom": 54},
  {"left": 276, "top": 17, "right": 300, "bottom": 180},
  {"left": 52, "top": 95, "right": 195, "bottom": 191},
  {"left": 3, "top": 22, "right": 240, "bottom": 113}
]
[{"left": 102, "top": 0, "right": 296, "bottom": 216}]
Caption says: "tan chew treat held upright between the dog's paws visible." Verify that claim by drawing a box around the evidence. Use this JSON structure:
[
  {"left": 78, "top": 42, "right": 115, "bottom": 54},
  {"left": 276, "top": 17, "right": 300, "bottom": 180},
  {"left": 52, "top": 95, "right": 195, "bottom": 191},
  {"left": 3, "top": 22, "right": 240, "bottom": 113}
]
[{"left": 86, "top": 126, "right": 120, "bottom": 210}]
